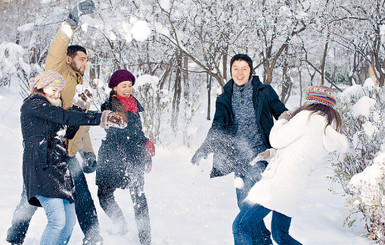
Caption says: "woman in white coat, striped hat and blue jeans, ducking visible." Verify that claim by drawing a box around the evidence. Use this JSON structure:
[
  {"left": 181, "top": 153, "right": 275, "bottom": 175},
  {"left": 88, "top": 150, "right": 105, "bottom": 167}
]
[{"left": 233, "top": 86, "right": 348, "bottom": 245}]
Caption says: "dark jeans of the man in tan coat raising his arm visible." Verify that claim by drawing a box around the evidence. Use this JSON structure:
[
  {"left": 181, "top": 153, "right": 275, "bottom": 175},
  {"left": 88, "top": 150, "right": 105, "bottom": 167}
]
[{"left": 7, "top": 157, "right": 103, "bottom": 244}]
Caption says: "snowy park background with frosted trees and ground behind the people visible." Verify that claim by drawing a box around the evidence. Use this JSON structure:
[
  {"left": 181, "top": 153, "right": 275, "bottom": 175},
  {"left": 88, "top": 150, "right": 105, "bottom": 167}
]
[{"left": 0, "top": 0, "right": 385, "bottom": 245}]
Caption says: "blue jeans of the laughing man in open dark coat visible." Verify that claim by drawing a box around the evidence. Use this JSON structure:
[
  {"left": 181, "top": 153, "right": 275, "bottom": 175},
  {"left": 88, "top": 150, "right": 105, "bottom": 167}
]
[{"left": 236, "top": 162, "right": 273, "bottom": 245}]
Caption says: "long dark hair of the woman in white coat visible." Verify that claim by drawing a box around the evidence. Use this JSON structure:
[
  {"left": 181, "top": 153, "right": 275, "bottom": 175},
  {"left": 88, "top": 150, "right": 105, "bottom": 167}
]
[{"left": 291, "top": 103, "right": 342, "bottom": 133}]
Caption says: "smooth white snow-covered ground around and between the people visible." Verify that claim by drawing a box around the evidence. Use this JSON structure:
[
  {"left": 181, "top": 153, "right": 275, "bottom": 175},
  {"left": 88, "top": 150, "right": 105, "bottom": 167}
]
[{"left": 0, "top": 88, "right": 370, "bottom": 245}]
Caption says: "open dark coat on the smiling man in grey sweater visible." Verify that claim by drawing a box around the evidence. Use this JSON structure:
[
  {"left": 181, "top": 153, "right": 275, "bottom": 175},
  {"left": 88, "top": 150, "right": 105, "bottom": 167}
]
[{"left": 198, "top": 76, "right": 287, "bottom": 178}]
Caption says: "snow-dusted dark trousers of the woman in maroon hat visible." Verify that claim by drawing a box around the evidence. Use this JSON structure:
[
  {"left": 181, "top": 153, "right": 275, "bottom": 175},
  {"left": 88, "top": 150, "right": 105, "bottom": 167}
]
[{"left": 98, "top": 179, "right": 151, "bottom": 245}]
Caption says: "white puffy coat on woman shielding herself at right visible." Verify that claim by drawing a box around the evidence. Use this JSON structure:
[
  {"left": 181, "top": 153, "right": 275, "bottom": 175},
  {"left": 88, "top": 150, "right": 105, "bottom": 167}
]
[{"left": 246, "top": 110, "right": 348, "bottom": 217}]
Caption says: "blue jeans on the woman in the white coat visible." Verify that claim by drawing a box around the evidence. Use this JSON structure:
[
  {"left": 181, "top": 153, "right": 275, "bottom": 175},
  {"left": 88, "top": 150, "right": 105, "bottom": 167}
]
[{"left": 233, "top": 203, "right": 301, "bottom": 245}]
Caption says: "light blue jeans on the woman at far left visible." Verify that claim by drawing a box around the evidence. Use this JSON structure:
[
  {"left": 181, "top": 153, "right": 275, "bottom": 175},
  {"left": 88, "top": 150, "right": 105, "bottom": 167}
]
[{"left": 36, "top": 196, "right": 76, "bottom": 245}]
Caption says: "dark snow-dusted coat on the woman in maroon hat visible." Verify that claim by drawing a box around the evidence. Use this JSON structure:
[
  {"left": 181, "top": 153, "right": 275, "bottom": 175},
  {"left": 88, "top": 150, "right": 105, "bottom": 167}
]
[{"left": 96, "top": 96, "right": 151, "bottom": 189}]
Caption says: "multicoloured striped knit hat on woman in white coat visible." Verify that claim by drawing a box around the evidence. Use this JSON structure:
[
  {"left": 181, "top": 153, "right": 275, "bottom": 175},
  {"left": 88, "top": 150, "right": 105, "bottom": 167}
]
[{"left": 304, "top": 86, "right": 336, "bottom": 108}]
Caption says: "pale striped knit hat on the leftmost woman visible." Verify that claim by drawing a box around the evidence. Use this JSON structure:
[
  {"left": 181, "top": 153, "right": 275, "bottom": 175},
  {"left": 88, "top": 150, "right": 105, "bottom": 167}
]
[{"left": 29, "top": 70, "right": 65, "bottom": 91}]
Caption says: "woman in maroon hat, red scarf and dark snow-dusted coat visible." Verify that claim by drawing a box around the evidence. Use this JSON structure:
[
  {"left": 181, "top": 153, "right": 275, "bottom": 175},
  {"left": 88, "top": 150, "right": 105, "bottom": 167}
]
[{"left": 96, "top": 70, "right": 155, "bottom": 244}]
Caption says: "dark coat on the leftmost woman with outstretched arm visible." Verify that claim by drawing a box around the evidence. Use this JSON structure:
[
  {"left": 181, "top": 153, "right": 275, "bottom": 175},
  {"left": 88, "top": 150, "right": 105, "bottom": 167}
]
[{"left": 20, "top": 95, "right": 101, "bottom": 206}]
